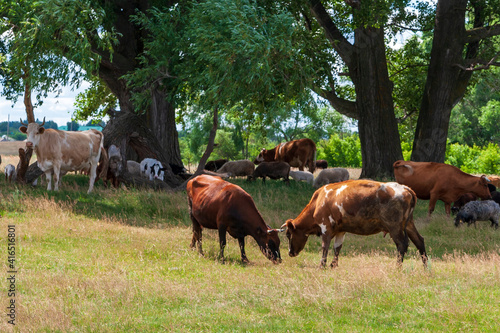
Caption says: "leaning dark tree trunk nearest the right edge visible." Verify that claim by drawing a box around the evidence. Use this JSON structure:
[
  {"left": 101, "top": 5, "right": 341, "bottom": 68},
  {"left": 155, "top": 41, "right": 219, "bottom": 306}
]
[{"left": 411, "top": 0, "right": 470, "bottom": 163}]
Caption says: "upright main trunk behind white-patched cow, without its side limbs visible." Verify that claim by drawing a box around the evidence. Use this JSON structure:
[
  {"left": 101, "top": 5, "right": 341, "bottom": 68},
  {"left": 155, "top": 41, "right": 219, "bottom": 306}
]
[{"left": 349, "top": 27, "right": 403, "bottom": 178}]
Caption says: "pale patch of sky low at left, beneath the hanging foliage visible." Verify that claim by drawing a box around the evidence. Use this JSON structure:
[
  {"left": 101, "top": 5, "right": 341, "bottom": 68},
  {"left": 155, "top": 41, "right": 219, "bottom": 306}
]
[{"left": 0, "top": 82, "right": 89, "bottom": 126}]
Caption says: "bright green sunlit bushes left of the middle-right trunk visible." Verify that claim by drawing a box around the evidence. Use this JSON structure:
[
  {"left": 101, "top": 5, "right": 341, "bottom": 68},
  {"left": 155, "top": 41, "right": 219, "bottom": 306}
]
[{"left": 317, "top": 134, "right": 361, "bottom": 168}]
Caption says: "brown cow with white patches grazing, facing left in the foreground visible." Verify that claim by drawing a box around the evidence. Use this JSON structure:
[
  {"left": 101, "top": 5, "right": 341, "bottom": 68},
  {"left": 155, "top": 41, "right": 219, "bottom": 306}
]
[{"left": 282, "top": 180, "right": 427, "bottom": 267}]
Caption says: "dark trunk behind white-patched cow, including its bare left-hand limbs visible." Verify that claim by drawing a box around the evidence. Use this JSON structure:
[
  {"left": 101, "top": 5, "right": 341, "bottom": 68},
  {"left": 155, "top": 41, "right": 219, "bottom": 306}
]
[{"left": 309, "top": 0, "right": 403, "bottom": 178}]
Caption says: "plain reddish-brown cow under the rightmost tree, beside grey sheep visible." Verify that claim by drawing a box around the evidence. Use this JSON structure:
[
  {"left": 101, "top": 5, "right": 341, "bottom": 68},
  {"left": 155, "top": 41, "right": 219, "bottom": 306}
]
[{"left": 393, "top": 160, "right": 491, "bottom": 218}]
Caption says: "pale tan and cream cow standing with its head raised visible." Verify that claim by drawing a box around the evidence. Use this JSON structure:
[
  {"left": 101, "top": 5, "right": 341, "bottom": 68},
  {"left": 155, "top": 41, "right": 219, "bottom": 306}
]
[{"left": 19, "top": 118, "right": 108, "bottom": 193}]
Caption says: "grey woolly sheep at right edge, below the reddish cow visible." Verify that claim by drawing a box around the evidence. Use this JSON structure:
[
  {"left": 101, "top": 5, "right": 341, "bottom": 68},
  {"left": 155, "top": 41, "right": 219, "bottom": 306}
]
[{"left": 455, "top": 200, "right": 500, "bottom": 228}]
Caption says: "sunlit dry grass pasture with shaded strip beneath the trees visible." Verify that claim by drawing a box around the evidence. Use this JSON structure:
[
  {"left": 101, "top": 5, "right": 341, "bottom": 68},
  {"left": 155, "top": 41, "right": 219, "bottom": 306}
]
[{"left": 0, "top": 150, "right": 500, "bottom": 332}]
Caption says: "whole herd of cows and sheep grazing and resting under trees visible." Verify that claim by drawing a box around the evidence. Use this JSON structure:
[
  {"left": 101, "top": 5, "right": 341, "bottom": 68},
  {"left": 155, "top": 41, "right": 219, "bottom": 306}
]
[{"left": 0, "top": 120, "right": 500, "bottom": 267}]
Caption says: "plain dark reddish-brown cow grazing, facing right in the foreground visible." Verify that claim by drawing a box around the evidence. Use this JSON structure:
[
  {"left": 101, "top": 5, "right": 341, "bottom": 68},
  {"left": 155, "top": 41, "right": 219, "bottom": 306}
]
[{"left": 187, "top": 175, "right": 281, "bottom": 263}]
